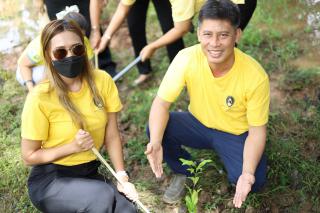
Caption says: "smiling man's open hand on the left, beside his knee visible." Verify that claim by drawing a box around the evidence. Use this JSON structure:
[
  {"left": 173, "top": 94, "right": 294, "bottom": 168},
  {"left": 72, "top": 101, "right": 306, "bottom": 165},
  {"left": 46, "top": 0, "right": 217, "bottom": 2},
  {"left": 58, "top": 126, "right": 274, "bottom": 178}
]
[{"left": 144, "top": 142, "right": 163, "bottom": 178}]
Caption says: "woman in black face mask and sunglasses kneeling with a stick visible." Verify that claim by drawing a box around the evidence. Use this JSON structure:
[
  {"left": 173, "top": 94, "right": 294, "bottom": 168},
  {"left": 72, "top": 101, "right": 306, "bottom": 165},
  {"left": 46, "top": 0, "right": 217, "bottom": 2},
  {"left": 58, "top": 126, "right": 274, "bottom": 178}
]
[{"left": 21, "top": 20, "right": 138, "bottom": 213}]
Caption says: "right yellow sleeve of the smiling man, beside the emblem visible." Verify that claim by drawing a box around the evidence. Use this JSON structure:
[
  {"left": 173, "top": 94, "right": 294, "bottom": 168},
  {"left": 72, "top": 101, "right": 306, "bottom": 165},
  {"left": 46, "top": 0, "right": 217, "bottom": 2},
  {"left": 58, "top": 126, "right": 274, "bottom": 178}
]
[{"left": 247, "top": 77, "right": 270, "bottom": 126}]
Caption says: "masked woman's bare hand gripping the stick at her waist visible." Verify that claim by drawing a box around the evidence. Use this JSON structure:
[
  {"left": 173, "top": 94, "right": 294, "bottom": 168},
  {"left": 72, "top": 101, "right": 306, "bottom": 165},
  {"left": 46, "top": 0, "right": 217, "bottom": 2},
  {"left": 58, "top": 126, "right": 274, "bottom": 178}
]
[{"left": 73, "top": 129, "right": 94, "bottom": 153}]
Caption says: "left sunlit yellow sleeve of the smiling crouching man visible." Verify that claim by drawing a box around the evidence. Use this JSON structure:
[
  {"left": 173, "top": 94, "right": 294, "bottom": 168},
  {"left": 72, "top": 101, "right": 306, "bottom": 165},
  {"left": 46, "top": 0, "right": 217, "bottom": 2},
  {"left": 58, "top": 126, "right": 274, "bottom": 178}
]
[{"left": 158, "top": 52, "right": 189, "bottom": 103}]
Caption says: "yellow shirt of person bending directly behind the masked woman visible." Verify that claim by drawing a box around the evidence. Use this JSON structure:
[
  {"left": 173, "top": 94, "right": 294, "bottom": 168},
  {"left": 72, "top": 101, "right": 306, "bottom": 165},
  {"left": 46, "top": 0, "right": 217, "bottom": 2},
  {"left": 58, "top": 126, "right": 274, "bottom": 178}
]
[{"left": 18, "top": 35, "right": 94, "bottom": 66}]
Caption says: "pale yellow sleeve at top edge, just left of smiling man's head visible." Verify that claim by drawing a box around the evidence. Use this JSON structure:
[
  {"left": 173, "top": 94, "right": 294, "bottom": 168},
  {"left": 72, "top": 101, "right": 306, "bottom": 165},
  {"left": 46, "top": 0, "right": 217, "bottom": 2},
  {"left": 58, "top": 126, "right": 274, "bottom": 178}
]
[{"left": 171, "top": 0, "right": 196, "bottom": 22}]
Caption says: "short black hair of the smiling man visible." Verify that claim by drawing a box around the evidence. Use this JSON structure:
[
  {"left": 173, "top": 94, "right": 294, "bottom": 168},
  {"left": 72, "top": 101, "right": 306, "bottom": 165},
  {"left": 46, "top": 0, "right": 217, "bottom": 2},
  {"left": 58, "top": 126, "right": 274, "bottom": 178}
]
[{"left": 198, "top": 0, "right": 240, "bottom": 28}]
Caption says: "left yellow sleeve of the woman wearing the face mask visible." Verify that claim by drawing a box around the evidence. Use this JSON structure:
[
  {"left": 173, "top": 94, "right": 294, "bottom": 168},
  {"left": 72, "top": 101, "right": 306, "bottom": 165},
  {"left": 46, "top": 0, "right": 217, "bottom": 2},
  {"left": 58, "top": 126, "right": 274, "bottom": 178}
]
[{"left": 21, "top": 92, "right": 49, "bottom": 141}]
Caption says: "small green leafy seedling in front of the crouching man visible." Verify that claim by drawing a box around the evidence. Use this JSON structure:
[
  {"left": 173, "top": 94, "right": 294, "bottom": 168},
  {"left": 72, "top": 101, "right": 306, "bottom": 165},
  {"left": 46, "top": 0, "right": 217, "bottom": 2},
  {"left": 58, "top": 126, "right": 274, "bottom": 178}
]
[{"left": 180, "top": 158, "right": 212, "bottom": 213}]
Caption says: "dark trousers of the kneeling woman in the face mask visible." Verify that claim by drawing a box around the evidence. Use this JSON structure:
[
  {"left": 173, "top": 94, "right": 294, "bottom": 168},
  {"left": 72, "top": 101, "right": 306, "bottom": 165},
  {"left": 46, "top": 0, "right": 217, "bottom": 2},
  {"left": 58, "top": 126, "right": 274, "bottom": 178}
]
[{"left": 28, "top": 161, "right": 137, "bottom": 213}]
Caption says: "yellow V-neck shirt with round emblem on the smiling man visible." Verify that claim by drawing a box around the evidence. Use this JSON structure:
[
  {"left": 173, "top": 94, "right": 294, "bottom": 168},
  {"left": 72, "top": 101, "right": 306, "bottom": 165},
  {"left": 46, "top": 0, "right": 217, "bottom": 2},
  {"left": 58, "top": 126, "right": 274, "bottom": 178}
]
[{"left": 158, "top": 44, "right": 270, "bottom": 135}]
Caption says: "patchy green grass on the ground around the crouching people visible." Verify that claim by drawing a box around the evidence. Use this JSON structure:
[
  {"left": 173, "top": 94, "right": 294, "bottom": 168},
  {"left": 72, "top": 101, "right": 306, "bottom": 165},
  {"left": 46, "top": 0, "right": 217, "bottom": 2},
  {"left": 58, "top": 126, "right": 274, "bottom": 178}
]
[{"left": 0, "top": 0, "right": 320, "bottom": 212}]
